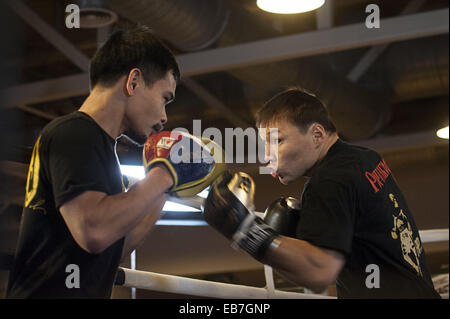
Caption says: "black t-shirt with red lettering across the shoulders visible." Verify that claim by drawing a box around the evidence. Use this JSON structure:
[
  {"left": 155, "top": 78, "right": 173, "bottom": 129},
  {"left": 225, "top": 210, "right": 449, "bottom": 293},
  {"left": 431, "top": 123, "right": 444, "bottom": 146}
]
[{"left": 297, "top": 140, "right": 439, "bottom": 298}]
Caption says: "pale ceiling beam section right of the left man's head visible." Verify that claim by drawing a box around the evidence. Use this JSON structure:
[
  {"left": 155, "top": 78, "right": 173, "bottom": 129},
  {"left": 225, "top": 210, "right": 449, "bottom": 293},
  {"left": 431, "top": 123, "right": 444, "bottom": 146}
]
[{"left": 177, "top": 9, "right": 449, "bottom": 76}]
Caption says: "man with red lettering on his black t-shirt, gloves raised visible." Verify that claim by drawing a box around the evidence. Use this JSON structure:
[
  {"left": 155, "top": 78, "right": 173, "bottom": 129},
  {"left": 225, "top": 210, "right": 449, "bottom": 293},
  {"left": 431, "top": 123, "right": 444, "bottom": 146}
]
[{"left": 204, "top": 89, "right": 440, "bottom": 298}]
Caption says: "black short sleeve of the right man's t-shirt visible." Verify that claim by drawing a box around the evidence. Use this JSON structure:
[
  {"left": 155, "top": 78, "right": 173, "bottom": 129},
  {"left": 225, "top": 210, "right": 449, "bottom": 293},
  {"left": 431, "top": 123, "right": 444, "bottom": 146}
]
[{"left": 297, "top": 176, "right": 355, "bottom": 255}]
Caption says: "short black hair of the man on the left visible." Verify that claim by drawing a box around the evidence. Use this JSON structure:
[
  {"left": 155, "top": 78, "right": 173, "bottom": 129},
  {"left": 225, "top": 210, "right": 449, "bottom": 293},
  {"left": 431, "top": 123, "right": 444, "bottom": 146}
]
[{"left": 89, "top": 25, "right": 180, "bottom": 89}]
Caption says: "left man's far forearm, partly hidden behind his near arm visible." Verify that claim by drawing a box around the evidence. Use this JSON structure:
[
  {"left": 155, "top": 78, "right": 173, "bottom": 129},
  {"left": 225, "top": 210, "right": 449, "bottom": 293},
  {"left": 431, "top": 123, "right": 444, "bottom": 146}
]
[{"left": 122, "top": 195, "right": 167, "bottom": 260}]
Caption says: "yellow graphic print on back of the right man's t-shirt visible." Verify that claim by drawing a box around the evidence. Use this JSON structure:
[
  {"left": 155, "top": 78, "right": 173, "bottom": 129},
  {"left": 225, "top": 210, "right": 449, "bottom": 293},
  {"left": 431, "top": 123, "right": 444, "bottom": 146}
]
[{"left": 389, "top": 194, "right": 422, "bottom": 276}]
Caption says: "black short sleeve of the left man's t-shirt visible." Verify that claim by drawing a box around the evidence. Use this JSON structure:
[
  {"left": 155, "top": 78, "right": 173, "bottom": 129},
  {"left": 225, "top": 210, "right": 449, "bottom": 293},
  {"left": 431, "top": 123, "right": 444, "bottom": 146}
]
[{"left": 46, "top": 120, "right": 113, "bottom": 209}]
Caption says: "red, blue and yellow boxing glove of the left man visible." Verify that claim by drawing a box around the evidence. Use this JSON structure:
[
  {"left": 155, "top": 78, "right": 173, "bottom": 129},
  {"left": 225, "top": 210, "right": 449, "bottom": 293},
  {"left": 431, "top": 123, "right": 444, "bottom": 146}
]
[{"left": 143, "top": 131, "right": 225, "bottom": 197}]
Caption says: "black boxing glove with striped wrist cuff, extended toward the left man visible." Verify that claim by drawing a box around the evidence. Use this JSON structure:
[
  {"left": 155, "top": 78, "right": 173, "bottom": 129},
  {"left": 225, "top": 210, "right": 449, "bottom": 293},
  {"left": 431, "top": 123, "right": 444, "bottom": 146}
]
[{"left": 203, "top": 171, "right": 278, "bottom": 260}]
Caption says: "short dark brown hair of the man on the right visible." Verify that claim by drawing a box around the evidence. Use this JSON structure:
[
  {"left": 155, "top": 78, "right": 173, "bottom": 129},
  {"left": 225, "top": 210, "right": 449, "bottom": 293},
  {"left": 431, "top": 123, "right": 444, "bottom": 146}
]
[{"left": 255, "top": 87, "right": 336, "bottom": 133}]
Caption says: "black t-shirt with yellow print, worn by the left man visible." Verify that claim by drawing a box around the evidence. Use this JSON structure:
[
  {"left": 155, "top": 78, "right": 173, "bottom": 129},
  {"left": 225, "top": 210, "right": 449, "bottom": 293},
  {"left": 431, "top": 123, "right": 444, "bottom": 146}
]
[{"left": 7, "top": 112, "right": 124, "bottom": 298}]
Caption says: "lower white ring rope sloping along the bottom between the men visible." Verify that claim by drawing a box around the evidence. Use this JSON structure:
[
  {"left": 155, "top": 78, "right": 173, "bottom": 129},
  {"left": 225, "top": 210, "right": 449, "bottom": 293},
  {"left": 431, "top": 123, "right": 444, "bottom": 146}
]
[{"left": 116, "top": 268, "right": 336, "bottom": 299}]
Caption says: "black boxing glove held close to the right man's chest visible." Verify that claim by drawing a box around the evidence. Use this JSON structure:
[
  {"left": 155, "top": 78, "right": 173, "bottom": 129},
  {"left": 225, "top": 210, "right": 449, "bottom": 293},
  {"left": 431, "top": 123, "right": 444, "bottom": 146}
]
[{"left": 264, "top": 197, "right": 300, "bottom": 238}]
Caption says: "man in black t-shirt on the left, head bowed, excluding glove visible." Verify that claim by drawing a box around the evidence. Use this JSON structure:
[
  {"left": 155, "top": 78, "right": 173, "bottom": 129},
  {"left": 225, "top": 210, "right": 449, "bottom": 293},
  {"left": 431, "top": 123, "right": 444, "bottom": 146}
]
[{"left": 7, "top": 26, "right": 180, "bottom": 298}]
